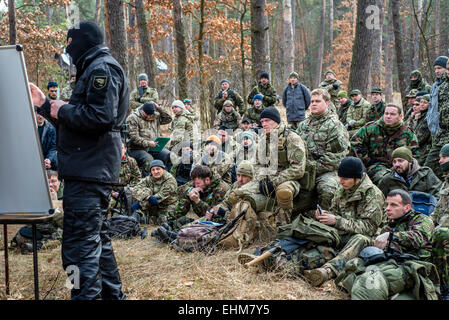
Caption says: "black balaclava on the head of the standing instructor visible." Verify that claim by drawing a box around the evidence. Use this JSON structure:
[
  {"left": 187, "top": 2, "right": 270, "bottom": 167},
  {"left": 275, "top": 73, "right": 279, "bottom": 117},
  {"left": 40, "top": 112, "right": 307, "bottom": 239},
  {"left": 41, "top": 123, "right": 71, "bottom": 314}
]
[{"left": 66, "top": 21, "right": 104, "bottom": 65}]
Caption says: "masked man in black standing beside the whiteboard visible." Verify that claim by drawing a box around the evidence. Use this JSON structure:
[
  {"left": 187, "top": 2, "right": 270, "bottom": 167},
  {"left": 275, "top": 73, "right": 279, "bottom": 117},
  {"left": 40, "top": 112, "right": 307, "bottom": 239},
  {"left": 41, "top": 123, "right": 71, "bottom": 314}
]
[{"left": 30, "top": 21, "right": 129, "bottom": 300}]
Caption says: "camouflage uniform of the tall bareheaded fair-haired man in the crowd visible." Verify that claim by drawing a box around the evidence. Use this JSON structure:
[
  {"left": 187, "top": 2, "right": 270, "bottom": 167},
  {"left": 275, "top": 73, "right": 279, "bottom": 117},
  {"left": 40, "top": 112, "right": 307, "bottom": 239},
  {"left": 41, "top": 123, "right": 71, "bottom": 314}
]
[{"left": 296, "top": 110, "right": 350, "bottom": 210}]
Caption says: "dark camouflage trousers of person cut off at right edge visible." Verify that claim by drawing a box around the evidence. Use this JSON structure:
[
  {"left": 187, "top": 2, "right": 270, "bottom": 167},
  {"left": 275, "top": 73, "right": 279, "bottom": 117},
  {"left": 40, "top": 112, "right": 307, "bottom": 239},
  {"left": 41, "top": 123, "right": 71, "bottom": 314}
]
[{"left": 432, "top": 228, "right": 449, "bottom": 286}]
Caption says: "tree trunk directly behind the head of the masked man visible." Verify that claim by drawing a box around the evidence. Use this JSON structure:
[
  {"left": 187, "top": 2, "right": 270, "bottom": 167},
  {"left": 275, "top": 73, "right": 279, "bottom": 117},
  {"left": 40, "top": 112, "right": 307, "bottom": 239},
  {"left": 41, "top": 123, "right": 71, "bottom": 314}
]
[{"left": 105, "top": 0, "right": 128, "bottom": 75}]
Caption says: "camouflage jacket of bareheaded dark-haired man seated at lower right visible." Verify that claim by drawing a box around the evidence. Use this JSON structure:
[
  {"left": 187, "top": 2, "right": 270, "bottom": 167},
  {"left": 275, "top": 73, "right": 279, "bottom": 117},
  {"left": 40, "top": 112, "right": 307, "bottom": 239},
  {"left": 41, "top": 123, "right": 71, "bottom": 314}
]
[{"left": 381, "top": 210, "right": 434, "bottom": 260}]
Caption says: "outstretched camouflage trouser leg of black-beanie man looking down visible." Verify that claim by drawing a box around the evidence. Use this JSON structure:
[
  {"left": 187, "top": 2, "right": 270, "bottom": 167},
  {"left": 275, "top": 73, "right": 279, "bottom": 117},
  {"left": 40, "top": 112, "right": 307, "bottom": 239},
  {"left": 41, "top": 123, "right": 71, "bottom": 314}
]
[{"left": 324, "top": 234, "right": 372, "bottom": 274}]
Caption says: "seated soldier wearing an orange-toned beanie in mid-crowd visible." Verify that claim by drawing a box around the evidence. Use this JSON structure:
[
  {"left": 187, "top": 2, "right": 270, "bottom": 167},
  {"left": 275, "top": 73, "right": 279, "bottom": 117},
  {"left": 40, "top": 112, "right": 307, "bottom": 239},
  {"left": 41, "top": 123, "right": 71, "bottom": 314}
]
[{"left": 200, "top": 136, "right": 234, "bottom": 184}]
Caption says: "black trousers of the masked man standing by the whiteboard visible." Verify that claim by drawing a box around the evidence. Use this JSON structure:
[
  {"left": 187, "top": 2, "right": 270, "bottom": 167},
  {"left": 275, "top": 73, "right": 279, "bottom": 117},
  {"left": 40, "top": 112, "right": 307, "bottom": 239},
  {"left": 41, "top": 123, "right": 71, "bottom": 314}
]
[{"left": 62, "top": 180, "right": 125, "bottom": 300}]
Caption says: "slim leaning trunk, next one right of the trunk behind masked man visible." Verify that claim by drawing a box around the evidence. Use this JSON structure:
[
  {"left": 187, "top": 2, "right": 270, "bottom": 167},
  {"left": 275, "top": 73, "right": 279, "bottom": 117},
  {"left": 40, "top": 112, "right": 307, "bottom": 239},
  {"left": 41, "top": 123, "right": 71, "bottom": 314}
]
[{"left": 135, "top": 0, "right": 156, "bottom": 87}]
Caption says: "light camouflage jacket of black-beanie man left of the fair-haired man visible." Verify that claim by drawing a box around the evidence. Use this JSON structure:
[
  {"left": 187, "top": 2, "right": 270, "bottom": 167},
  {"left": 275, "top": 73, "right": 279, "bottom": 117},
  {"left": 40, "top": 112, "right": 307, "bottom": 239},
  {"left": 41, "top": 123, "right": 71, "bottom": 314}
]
[{"left": 254, "top": 123, "right": 307, "bottom": 187}]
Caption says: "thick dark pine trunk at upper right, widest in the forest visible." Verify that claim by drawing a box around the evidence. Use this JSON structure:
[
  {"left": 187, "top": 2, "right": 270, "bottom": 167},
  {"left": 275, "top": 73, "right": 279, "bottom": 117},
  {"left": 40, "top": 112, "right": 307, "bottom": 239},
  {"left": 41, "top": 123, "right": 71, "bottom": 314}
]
[{"left": 348, "top": 0, "right": 376, "bottom": 97}]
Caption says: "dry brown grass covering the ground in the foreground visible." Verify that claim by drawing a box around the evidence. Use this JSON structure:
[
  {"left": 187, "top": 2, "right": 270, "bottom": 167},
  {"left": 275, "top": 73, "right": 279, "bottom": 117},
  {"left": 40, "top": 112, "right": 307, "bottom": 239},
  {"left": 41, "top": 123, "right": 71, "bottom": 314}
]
[{"left": 0, "top": 226, "right": 347, "bottom": 300}]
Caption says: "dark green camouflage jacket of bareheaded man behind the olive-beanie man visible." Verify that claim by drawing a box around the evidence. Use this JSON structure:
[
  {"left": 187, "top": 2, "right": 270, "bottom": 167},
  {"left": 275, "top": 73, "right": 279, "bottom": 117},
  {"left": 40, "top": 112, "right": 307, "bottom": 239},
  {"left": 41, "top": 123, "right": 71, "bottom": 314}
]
[{"left": 351, "top": 118, "right": 419, "bottom": 169}]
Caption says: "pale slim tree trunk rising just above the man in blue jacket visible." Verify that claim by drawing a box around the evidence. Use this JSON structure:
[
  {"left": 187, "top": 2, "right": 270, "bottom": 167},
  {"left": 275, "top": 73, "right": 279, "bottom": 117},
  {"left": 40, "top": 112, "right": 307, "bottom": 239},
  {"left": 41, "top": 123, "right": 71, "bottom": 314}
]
[{"left": 282, "top": 0, "right": 295, "bottom": 79}]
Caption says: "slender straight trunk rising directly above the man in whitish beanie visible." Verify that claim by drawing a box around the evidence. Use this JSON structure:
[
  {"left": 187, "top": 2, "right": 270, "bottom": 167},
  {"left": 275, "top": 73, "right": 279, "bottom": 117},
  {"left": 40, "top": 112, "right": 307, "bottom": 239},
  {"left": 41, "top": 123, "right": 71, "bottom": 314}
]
[{"left": 173, "top": 0, "right": 187, "bottom": 99}]
